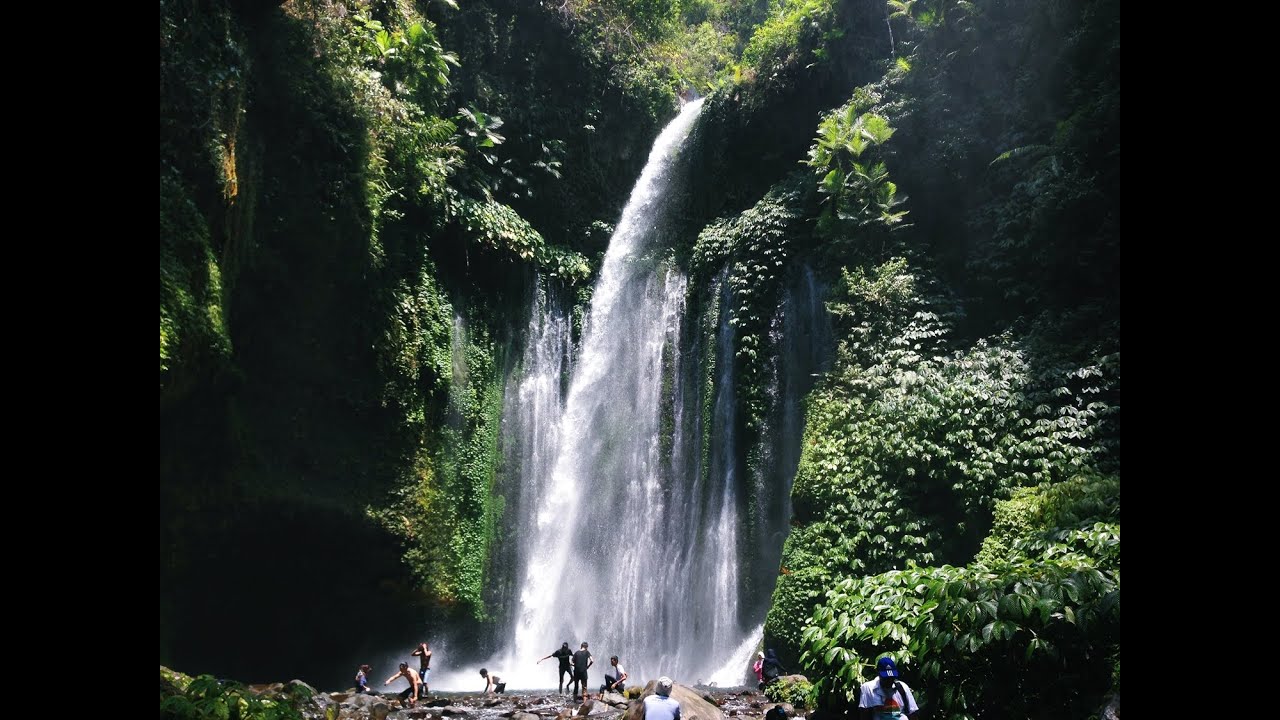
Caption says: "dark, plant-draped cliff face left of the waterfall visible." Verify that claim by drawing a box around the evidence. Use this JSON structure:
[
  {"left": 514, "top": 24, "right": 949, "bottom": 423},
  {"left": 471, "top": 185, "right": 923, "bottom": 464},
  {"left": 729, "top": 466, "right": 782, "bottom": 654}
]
[{"left": 160, "top": 0, "right": 675, "bottom": 679}]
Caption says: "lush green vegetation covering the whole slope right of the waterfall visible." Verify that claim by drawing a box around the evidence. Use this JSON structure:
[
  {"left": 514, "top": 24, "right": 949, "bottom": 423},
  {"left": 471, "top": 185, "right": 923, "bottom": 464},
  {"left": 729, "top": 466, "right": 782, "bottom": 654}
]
[{"left": 689, "top": 0, "right": 1120, "bottom": 717}]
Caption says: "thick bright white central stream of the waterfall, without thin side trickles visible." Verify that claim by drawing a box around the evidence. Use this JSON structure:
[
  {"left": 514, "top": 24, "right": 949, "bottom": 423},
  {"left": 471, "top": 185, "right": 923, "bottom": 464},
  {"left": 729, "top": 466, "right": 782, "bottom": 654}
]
[{"left": 495, "top": 95, "right": 721, "bottom": 688}]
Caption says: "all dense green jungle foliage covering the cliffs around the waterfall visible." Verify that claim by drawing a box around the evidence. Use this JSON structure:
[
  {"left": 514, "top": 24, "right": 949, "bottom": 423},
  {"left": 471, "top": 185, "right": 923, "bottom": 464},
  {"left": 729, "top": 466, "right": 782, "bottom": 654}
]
[{"left": 160, "top": 0, "right": 1120, "bottom": 717}]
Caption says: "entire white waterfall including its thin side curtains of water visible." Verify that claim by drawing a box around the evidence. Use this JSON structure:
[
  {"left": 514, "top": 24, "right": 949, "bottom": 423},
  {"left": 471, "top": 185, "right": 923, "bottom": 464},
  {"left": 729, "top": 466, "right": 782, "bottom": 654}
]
[{"left": 431, "top": 100, "right": 826, "bottom": 692}]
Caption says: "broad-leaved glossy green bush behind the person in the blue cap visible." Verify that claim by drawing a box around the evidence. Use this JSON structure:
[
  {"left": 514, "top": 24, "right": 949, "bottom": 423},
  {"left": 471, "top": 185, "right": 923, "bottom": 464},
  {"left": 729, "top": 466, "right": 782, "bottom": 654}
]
[{"left": 803, "top": 477, "right": 1120, "bottom": 717}]
